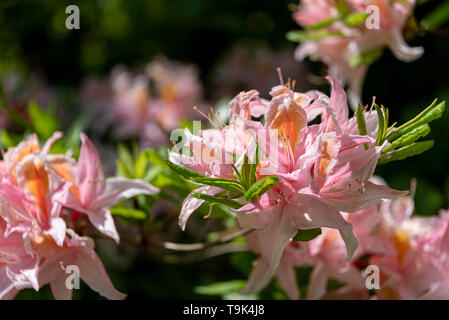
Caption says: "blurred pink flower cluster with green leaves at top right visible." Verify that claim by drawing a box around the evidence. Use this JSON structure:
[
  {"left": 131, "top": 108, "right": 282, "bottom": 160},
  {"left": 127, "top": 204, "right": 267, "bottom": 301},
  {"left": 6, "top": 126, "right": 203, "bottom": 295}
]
[{"left": 289, "top": 0, "right": 423, "bottom": 109}]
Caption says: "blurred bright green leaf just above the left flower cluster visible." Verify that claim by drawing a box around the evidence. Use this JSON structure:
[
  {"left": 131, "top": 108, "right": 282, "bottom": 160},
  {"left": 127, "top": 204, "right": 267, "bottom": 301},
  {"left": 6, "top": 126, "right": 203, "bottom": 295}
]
[{"left": 28, "top": 101, "right": 59, "bottom": 140}]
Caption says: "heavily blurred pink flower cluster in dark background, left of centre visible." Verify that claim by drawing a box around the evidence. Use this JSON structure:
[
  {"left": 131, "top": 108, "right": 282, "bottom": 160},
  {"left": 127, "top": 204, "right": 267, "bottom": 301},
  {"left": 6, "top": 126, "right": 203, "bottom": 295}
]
[{"left": 82, "top": 58, "right": 202, "bottom": 147}]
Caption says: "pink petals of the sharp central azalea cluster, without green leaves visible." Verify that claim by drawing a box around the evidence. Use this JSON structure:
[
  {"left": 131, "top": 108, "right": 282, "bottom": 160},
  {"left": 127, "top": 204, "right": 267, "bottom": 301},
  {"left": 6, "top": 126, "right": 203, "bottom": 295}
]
[{"left": 170, "top": 78, "right": 404, "bottom": 296}]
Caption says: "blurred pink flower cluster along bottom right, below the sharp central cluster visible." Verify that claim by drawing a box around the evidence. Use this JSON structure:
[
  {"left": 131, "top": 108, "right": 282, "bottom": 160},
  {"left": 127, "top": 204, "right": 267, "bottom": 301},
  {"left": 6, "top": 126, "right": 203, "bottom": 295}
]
[{"left": 243, "top": 185, "right": 449, "bottom": 300}]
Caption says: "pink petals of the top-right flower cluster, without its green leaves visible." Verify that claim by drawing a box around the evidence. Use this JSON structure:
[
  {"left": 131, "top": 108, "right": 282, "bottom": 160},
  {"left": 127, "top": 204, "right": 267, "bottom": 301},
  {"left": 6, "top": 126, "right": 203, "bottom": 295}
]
[{"left": 293, "top": 0, "right": 423, "bottom": 109}]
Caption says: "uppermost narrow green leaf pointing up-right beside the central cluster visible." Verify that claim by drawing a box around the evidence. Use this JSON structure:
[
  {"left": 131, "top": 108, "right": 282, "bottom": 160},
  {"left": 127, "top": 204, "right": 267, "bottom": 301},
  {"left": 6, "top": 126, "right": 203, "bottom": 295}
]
[{"left": 387, "top": 99, "right": 446, "bottom": 142}]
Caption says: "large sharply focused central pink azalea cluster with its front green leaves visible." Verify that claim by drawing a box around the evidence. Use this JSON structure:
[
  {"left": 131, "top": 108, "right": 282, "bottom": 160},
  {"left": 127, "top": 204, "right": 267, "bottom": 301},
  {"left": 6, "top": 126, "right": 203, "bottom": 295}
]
[{"left": 170, "top": 78, "right": 434, "bottom": 298}]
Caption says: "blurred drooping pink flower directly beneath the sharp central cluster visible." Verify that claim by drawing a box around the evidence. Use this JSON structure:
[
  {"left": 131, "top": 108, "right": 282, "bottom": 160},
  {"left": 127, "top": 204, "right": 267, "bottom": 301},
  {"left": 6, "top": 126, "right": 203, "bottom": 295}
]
[{"left": 241, "top": 229, "right": 365, "bottom": 300}]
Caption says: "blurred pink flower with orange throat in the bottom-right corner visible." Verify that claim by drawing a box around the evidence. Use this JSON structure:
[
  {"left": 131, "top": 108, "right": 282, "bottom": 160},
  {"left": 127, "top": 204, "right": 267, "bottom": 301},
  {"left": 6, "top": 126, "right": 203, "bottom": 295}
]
[{"left": 350, "top": 192, "right": 449, "bottom": 299}]
